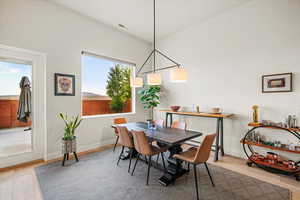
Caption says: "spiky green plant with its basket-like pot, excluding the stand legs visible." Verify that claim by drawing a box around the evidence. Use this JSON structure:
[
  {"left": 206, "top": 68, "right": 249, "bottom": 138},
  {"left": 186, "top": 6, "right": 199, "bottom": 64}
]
[{"left": 59, "top": 113, "right": 82, "bottom": 155}]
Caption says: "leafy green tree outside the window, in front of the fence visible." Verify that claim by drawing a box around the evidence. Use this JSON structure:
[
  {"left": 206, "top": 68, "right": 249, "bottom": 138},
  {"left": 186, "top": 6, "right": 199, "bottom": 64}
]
[{"left": 106, "top": 64, "right": 131, "bottom": 112}]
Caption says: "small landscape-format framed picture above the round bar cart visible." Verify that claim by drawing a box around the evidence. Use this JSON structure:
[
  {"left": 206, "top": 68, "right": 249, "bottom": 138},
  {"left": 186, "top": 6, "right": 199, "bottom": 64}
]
[{"left": 262, "top": 73, "right": 293, "bottom": 93}]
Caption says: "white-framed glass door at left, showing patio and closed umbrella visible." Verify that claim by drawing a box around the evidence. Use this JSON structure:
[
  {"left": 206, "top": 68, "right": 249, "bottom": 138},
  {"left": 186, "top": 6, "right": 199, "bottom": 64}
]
[{"left": 0, "top": 45, "right": 46, "bottom": 168}]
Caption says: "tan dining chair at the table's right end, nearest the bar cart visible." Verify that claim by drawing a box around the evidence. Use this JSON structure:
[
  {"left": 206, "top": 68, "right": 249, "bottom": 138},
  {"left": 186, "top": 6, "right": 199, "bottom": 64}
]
[{"left": 173, "top": 134, "right": 216, "bottom": 200}]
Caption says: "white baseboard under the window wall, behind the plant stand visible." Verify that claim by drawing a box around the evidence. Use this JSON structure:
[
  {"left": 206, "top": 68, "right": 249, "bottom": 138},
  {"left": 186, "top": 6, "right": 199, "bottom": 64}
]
[{"left": 45, "top": 138, "right": 116, "bottom": 161}]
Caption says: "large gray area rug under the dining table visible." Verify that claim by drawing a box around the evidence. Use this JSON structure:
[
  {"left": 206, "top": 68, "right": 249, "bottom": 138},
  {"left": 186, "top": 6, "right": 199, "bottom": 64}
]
[{"left": 36, "top": 148, "right": 290, "bottom": 200}]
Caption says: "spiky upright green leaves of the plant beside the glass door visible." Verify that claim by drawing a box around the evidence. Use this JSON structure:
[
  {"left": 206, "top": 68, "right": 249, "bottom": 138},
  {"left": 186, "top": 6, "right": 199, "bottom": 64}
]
[{"left": 59, "top": 113, "right": 82, "bottom": 140}]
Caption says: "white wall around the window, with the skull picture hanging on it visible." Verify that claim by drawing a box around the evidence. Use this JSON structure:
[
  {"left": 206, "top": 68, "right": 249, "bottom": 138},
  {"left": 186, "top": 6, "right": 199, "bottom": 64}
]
[{"left": 0, "top": 0, "right": 150, "bottom": 158}]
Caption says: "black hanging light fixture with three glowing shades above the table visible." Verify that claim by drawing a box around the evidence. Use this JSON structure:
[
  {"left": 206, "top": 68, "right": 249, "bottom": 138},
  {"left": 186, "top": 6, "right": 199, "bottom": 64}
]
[{"left": 131, "top": 0, "right": 187, "bottom": 87}]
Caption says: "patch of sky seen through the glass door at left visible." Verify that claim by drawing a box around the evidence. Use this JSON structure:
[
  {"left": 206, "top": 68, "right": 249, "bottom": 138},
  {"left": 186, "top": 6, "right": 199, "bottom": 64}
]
[{"left": 0, "top": 61, "right": 31, "bottom": 96}]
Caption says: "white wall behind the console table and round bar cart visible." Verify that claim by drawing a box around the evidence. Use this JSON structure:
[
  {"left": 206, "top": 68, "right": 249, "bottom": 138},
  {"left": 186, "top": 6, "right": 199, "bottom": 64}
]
[{"left": 157, "top": 0, "right": 300, "bottom": 160}]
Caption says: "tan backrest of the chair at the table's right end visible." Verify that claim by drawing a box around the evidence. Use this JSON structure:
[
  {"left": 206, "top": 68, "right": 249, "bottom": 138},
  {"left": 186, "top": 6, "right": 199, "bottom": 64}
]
[{"left": 194, "top": 134, "right": 217, "bottom": 163}]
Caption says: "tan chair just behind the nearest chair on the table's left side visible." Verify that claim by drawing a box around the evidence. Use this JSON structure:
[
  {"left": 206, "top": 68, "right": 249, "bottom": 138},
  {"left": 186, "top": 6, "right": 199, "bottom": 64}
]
[{"left": 117, "top": 126, "right": 134, "bottom": 173}]
